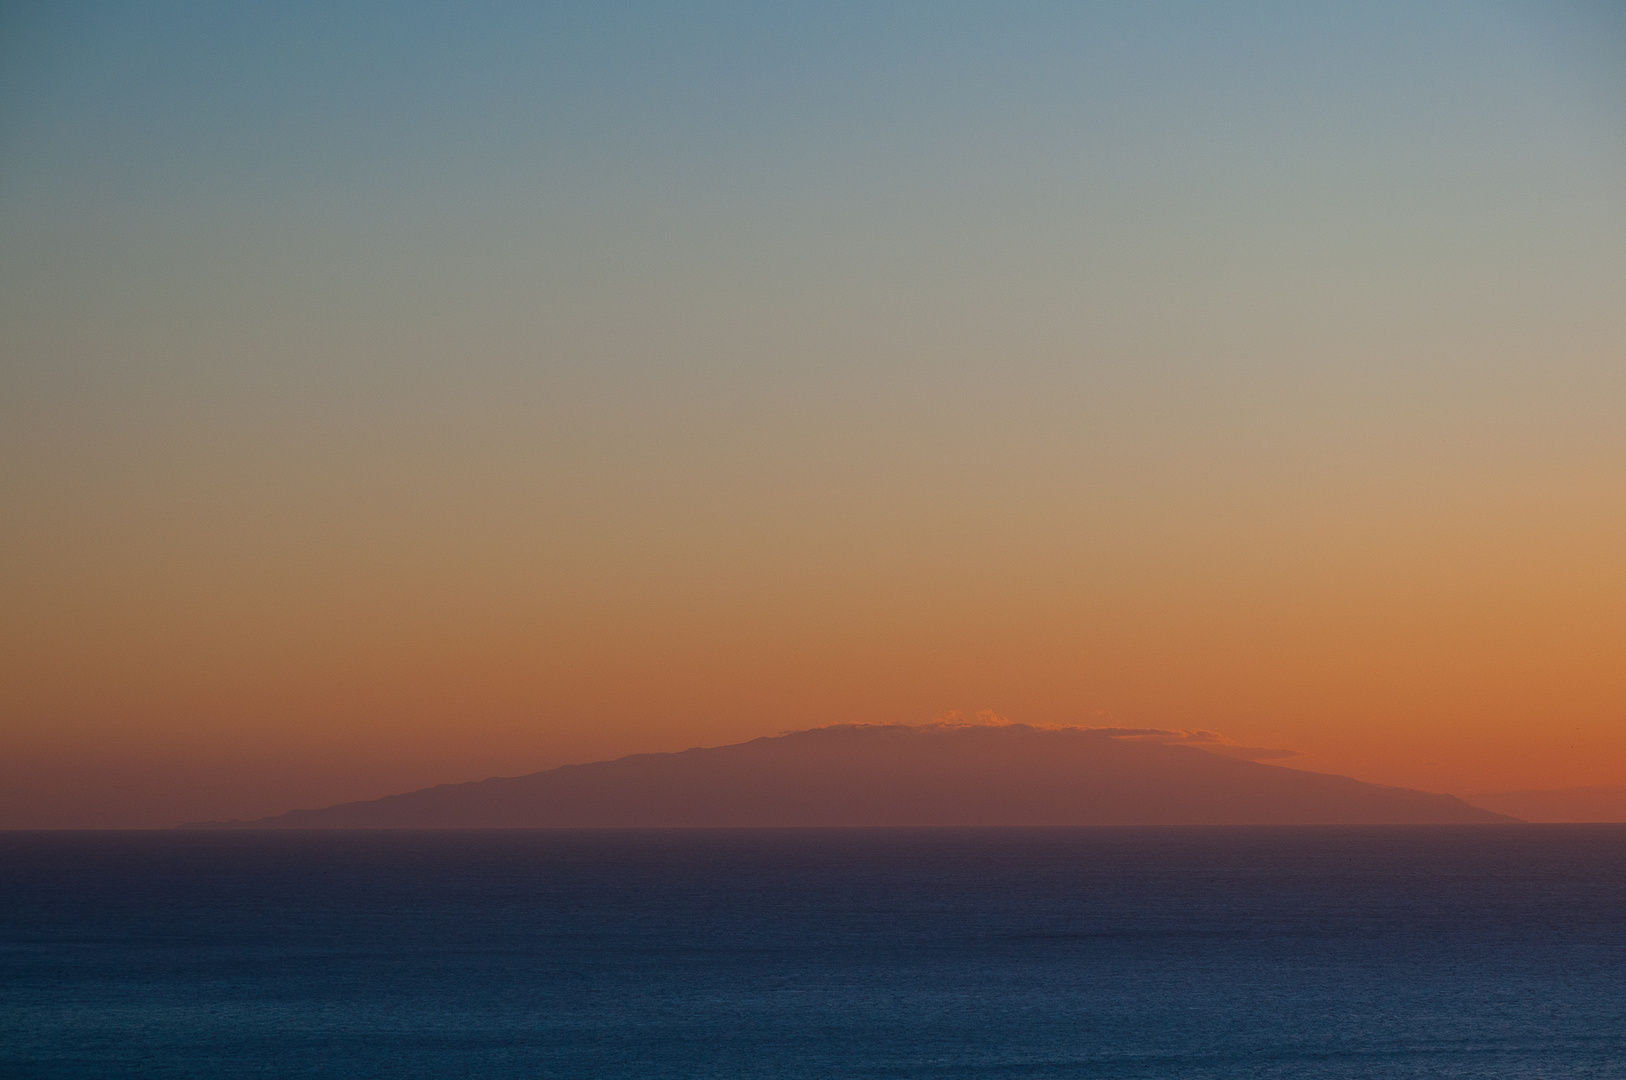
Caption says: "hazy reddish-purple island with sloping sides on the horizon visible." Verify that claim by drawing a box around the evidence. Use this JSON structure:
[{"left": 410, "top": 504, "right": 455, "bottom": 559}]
[{"left": 182, "top": 724, "right": 1517, "bottom": 830}]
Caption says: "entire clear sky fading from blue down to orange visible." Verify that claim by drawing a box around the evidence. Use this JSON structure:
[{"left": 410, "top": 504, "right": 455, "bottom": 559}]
[{"left": 0, "top": 0, "right": 1626, "bottom": 828}]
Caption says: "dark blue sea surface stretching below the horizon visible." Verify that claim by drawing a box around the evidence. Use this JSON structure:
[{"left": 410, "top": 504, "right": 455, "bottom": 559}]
[{"left": 0, "top": 826, "right": 1626, "bottom": 1080}]
